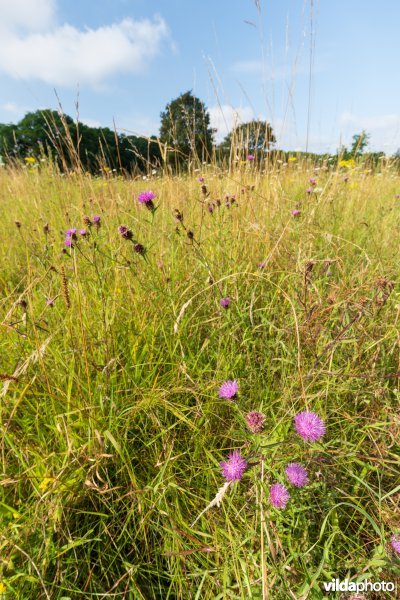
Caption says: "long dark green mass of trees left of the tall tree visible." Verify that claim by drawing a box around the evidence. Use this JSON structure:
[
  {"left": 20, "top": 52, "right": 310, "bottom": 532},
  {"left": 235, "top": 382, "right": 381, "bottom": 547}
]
[{"left": 0, "top": 109, "right": 161, "bottom": 172}]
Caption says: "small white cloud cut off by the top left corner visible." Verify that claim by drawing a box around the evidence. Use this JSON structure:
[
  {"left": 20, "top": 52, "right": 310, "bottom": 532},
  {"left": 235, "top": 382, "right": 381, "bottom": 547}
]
[{"left": 0, "top": 0, "right": 55, "bottom": 35}]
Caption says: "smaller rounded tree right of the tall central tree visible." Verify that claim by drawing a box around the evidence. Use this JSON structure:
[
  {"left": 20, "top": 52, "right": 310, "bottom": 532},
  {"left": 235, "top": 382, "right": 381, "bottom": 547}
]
[{"left": 221, "top": 119, "right": 276, "bottom": 158}]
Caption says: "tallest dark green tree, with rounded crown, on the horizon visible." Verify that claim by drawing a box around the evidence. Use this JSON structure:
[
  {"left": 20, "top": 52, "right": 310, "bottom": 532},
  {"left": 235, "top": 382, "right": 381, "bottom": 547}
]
[{"left": 160, "top": 92, "right": 213, "bottom": 163}]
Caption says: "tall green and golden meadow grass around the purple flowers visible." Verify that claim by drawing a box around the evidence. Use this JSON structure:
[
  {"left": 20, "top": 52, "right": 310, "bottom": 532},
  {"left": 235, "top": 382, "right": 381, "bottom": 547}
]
[{"left": 0, "top": 162, "right": 400, "bottom": 600}]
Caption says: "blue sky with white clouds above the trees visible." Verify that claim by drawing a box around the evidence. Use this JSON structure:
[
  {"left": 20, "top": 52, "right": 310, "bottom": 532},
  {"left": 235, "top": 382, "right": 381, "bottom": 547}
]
[{"left": 0, "top": 0, "right": 400, "bottom": 154}]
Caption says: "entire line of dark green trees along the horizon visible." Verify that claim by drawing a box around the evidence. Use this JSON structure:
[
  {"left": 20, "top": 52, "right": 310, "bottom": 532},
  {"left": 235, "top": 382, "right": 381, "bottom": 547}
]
[{"left": 0, "top": 91, "right": 384, "bottom": 174}]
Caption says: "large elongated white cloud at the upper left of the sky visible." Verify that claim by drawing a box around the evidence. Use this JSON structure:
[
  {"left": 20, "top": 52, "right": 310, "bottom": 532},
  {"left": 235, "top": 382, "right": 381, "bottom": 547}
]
[{"left": 0, "top": 0, "right": 169, "bottom": 87}]
